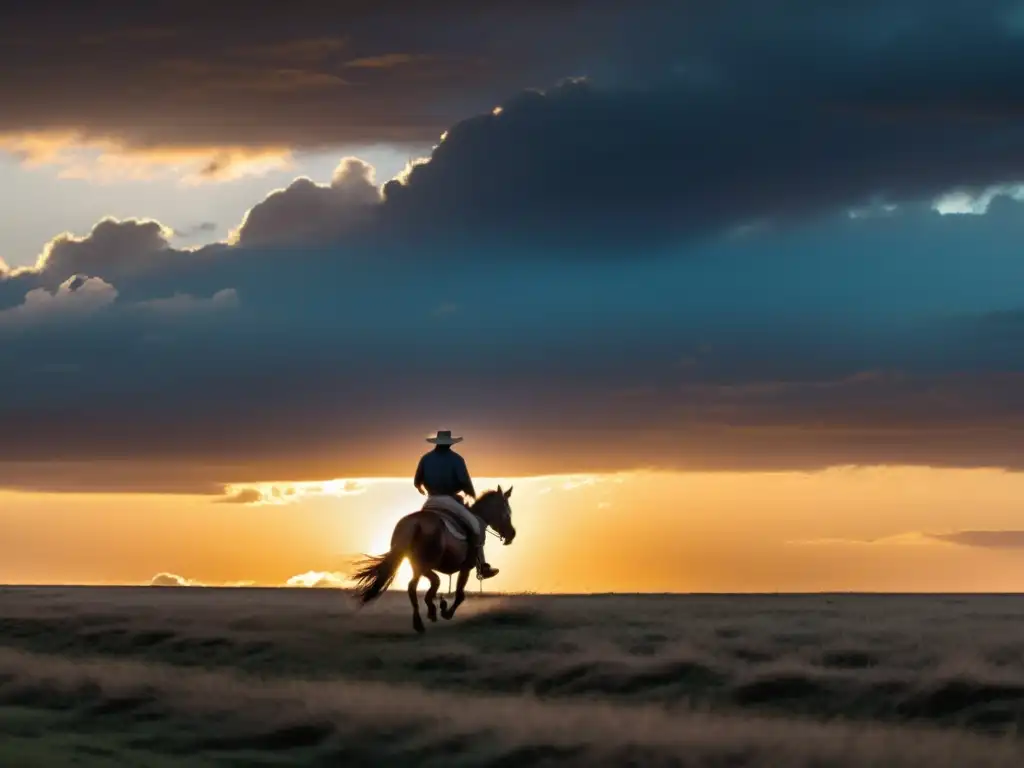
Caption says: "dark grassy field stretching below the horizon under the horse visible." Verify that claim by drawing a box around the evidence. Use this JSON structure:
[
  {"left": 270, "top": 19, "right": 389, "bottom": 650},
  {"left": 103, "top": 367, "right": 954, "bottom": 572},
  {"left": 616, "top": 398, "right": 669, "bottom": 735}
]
[{"left": 0, "top": 588, "right": 1024, "bottom": 768}]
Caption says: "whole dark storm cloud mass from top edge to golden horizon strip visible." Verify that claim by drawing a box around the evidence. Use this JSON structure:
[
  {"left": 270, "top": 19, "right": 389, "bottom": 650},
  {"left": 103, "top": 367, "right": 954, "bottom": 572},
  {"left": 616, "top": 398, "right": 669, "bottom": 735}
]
[{"left": 0, "top": 0, "right": 1024, "bottom": 493}]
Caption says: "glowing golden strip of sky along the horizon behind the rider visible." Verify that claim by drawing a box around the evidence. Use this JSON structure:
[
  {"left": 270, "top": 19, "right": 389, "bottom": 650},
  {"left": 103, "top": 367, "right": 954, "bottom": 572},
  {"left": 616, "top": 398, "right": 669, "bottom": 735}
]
[{"left": 6, "top": 467, "right": 1024, "bottom": 594}]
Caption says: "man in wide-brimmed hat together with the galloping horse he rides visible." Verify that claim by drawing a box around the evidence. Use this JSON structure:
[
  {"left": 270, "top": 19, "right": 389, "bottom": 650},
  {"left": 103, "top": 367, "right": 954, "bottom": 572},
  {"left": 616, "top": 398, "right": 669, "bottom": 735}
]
[{"left": 354, "top": 430, "right": 515, "bottom": 633}]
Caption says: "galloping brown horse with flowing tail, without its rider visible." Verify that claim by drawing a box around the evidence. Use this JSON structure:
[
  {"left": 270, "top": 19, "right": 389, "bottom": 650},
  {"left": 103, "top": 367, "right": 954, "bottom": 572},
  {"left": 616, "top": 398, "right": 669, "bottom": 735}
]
[{"left": 353, "top": 485, "right": 515, "bottom": 632}]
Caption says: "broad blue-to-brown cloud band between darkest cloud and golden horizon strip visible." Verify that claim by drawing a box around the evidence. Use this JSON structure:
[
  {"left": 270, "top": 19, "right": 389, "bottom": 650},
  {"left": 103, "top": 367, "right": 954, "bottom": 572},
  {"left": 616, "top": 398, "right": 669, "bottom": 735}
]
[{"left": 6, "top": 163, "right": 1024, "bottom": 493}]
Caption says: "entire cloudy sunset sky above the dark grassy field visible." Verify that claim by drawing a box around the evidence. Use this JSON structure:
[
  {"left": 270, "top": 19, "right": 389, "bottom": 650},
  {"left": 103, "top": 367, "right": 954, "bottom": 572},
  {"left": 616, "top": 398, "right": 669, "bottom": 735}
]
[{"left": 0, "top": 0, "right": 1024, "bottom": 592}]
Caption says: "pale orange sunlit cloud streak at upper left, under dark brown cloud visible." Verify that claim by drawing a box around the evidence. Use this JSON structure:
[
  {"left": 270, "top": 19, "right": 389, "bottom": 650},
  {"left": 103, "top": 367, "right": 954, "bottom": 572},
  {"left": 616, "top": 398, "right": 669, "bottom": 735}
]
[{"left": 0, "top": 131, "right": 294, "bottom": 185}]
